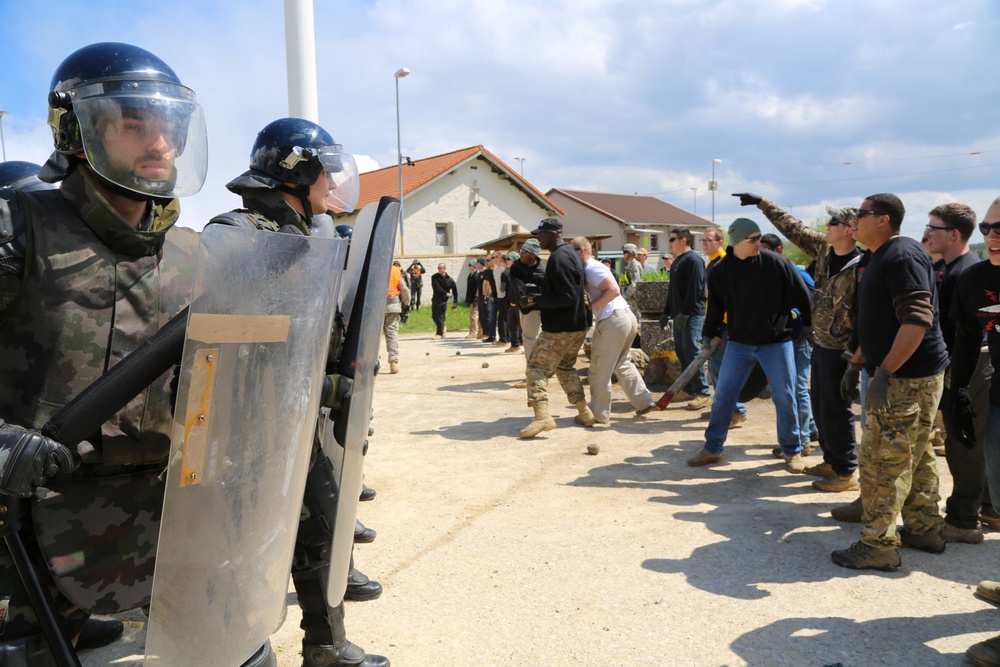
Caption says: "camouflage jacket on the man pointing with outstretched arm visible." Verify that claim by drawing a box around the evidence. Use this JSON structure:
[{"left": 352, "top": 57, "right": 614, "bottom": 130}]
[{"left": 758, "top": 199, "right": 861, "bottom": 350}]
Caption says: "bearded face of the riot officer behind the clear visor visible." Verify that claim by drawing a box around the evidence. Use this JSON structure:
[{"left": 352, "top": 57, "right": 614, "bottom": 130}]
[{"left": 101, "top": 109, "right": 177, "bottom": 182}]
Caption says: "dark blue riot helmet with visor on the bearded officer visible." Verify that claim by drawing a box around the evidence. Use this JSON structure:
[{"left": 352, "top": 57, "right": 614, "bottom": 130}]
[{"left": 41, "top": 42, "right": 208, "bottom": 197}]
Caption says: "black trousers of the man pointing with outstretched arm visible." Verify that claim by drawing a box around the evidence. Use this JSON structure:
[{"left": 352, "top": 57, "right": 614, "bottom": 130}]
[{"left": 809, "top": 345, "right": 858, "bottom": 475}]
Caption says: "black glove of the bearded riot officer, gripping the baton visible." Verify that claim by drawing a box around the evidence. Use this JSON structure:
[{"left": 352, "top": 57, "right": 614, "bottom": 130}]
[{"left": 0, "top": 420, "right": 80, "bottom": 498}]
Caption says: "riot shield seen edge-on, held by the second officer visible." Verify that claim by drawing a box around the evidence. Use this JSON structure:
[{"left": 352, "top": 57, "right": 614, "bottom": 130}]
[{"left": 323, "top": 197, "right": 399, "bottom": 606}]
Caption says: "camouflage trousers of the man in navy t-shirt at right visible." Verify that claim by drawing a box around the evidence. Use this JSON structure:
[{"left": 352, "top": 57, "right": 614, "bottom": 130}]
[{"left": 858, "top": 371, "right": 944, "bottom": 549}]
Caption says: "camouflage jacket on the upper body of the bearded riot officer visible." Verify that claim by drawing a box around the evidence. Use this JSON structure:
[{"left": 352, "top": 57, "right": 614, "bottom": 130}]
[{"left": 0, "top": 168, "right": 198, "bottom": 465}]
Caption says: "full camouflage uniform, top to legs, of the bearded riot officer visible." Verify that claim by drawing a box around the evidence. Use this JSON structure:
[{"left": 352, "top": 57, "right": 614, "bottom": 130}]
[{"left": 0, "top": 168, "right": 198, "bottom": 652}]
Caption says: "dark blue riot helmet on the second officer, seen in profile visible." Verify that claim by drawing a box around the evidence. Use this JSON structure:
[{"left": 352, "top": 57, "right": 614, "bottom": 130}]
[{"left": 226, "top": 118, "right": 360, "bottom": 218}]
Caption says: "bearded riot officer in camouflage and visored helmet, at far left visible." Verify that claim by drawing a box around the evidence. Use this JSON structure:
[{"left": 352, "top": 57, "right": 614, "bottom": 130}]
[{"left": 0, "top": 43, "right": 213, "bottom": 667}]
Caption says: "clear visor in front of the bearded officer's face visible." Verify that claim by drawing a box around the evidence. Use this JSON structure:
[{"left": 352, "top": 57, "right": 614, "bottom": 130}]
[{"left": 73, "top": 82, "right": 208, "bottom": 198}]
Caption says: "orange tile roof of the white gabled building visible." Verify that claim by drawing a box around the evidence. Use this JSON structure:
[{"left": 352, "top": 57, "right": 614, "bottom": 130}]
[{"left": 355, "top": 146, "right": 565, "bottom": 214}]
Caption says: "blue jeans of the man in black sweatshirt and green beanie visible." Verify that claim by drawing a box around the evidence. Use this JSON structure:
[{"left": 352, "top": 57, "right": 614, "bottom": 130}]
[{"left": 705, "top": 340, "right": 802, "bottom": 456}]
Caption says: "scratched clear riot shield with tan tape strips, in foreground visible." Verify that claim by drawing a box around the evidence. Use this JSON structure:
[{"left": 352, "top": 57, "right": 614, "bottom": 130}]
[{"left": 144, "top": 225, "right": 347, "bottom": 667}]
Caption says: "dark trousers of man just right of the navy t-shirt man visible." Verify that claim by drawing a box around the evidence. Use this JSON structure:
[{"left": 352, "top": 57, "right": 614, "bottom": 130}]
[{"left": 944, "top": 352, "right": 993, "bottom": 528}]
